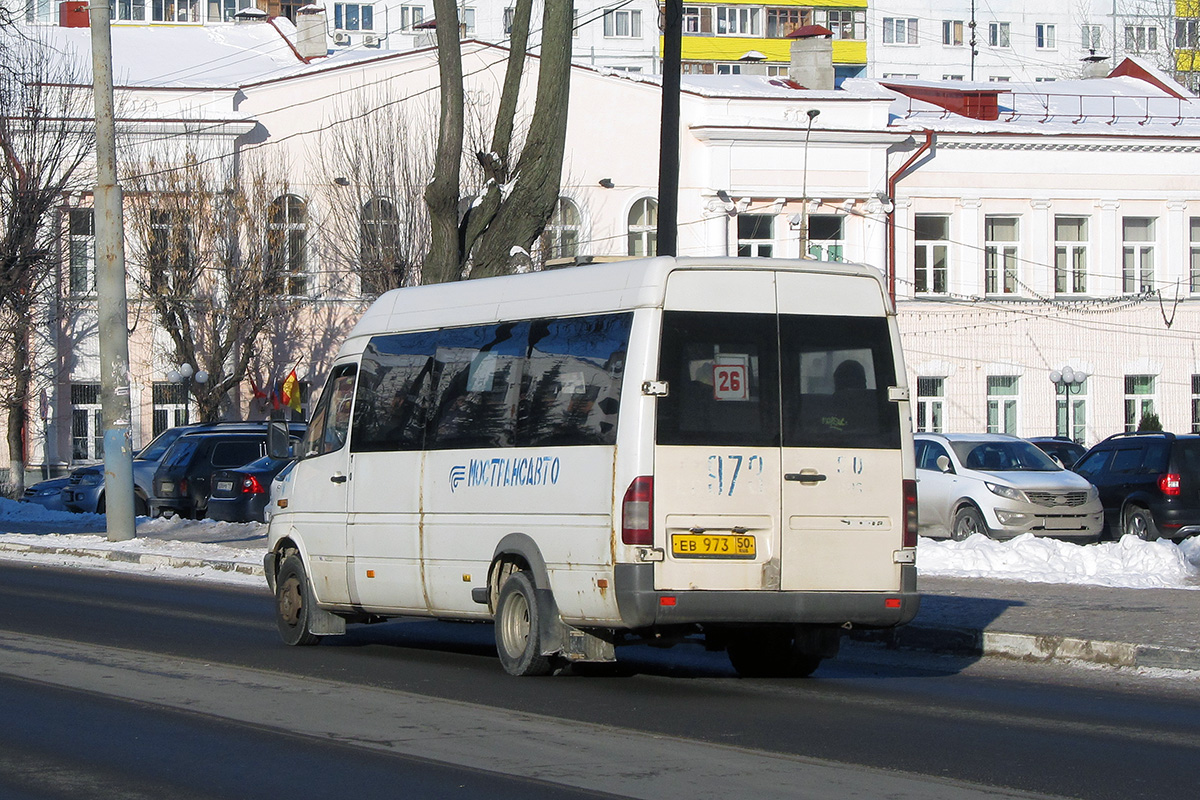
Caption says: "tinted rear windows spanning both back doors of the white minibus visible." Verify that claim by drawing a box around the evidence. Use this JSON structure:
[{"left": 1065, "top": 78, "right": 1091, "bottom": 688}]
[{"left": 656, "top": 311, "right": 900, "bottom": 449}]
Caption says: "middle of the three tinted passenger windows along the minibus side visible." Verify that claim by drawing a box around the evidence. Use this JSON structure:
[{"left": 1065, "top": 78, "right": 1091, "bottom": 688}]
[{"left": 425, "top": 323, "right": 529, "bottom": 450}]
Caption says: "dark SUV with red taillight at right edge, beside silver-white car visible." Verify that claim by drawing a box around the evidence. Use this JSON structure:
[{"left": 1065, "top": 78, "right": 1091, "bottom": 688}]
[{"left": 1074, "top": 433, "right": 1200, "bottom": 541}]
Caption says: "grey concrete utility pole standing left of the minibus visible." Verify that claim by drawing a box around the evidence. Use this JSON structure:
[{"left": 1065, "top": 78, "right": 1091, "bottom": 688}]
[{"left": 88, "top": 0, "right": 134, "bottom": 542}]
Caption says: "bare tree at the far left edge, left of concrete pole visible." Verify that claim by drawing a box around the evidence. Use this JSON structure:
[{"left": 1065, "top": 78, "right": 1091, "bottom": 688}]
[{"left": 0, "top": 36, "right": 95, "bottom": 491}]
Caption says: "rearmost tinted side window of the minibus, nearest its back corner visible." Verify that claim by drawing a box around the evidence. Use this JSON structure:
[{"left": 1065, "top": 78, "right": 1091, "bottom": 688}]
[{"left": 516, "top": 314, "right": 634, "bottom": 446}]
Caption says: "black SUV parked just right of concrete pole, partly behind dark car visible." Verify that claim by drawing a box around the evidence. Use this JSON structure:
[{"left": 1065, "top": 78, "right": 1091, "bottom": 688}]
[{"left": 150, "top": 422, "right": 296, "bottom": 519}]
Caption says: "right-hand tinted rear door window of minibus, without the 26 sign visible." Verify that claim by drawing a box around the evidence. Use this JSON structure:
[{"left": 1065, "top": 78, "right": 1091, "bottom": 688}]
[{"left": 780, "top": 314, "right": 900, "bottom": 449}]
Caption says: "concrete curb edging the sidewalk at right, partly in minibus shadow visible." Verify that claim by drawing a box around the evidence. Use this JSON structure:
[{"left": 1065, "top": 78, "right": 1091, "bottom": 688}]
[{"left": 851, "top": 625, "right": 1200, "bottom": 670}]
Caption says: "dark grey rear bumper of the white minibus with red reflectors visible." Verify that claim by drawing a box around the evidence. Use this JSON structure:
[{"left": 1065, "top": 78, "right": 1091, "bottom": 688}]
[{"left": 613, "top": 564, "right": 920, "bottom": 628}]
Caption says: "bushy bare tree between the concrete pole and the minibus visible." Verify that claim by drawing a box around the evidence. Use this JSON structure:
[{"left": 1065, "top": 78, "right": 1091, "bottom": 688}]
[{"left": 122, "top": 149, "right": 311, "bottom": 421}]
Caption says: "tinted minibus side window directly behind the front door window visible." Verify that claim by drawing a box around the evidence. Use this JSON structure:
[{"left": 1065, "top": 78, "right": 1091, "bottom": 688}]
[{"left": 350, "top": 331, "right": 438, "bottom": 452}]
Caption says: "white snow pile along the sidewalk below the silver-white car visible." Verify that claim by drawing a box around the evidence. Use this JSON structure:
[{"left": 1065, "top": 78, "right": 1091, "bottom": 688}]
[{"left": 917, "top": 534, "right": 1200, "bottom": 589}]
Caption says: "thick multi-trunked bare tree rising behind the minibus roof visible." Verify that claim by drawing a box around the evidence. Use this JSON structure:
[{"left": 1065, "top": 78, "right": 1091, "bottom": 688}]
[{"left": 425, "top": 0, "right": 575, "bottom": 282}]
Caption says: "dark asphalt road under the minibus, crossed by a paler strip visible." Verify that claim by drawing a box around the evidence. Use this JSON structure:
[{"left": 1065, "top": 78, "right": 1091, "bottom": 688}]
[{"left": 0, "top": 564, "right": 1200, "bottom": 800}]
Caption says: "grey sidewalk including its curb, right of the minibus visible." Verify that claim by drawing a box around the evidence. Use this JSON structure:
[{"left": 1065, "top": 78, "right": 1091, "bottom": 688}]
[{"left": 856, "top": 576, "right": 1200, "bottom": 670}]
